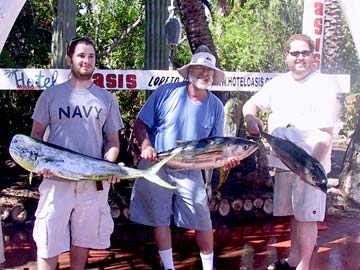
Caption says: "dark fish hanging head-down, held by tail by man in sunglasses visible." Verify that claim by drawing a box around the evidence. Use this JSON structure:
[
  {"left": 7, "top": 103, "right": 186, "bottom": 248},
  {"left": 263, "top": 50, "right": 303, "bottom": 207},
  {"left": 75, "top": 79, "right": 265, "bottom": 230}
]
[{"left": 260, "top": 131, "right": 327, "bottom": 193}]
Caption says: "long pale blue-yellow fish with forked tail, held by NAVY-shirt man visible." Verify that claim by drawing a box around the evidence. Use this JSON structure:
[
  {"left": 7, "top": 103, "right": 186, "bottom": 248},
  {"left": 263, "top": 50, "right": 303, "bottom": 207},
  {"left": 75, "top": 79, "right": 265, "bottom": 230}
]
[{"left": 9, "top": 134, "right": 180, "bottom": 189}]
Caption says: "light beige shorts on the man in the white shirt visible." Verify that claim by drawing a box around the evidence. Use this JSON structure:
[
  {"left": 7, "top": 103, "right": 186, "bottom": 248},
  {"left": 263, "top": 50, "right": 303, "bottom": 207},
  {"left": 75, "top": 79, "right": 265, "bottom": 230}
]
[{"left": 273, "top": 172, "right": 326, "bottom": 221}]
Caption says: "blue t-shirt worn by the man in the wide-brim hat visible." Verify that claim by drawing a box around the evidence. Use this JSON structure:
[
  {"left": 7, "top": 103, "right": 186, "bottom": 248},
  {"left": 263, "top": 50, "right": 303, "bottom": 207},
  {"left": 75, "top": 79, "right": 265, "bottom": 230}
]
[{"left": 138, "top": 82, "right": 224, "bottom": 152}]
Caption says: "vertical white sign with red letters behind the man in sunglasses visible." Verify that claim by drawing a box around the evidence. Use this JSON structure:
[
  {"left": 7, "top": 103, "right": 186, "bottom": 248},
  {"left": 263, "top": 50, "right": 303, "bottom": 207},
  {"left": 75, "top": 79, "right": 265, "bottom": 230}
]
[{"left": 302, "top": 0, "right": 325, "bottom": 70}]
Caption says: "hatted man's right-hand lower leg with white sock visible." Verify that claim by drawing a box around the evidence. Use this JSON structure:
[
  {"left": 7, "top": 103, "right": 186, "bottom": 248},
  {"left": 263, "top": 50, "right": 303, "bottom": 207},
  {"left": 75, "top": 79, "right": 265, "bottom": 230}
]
[{"left": 196, "top": 230, "right": 214, "bottom": 270}]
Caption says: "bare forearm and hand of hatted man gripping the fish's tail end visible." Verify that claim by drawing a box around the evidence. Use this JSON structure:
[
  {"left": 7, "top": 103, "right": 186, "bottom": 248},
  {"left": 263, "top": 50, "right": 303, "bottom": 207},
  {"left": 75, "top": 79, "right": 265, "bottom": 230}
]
[{"left": 133, "top": 118, "right": 157, "bottom": 161}]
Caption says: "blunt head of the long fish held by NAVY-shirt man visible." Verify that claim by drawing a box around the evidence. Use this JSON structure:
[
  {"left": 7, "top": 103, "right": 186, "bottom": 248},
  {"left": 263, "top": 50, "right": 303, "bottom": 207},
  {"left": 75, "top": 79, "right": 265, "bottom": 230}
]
[{"left": 9, "top": 134, "right": 38, "bottom": 171}]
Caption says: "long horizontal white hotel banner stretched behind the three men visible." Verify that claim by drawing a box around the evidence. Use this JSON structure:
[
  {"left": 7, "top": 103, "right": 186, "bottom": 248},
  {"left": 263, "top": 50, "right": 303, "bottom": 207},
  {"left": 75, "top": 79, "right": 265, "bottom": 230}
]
[{"left": 0, "top": 68, "right": 350, "bottom": 93}]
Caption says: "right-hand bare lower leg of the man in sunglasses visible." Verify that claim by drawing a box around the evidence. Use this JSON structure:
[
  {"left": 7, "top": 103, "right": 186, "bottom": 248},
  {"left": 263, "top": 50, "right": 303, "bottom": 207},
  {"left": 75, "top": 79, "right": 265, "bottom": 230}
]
[{"left": 296, "top": 221, "right": 318, "bottom": 270}]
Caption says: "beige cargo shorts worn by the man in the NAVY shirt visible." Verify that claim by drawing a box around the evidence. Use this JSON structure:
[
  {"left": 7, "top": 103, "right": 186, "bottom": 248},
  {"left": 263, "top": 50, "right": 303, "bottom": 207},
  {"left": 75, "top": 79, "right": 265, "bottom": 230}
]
[{"left": 33, "top": 179, "right": 114, "bottom": 258}]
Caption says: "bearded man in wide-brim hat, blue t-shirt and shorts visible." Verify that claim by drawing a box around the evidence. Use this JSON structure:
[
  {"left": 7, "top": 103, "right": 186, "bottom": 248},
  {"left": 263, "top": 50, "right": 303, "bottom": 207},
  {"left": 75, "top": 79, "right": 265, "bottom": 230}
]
[{"left": 130, "top": 47, "right": 238, "bottom": 270}]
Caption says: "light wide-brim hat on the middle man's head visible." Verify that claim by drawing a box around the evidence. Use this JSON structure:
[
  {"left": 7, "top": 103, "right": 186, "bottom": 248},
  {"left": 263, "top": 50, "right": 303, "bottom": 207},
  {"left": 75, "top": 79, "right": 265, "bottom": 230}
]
[{"left": 177, "top": 52, "right": 225, "bottom": 84}]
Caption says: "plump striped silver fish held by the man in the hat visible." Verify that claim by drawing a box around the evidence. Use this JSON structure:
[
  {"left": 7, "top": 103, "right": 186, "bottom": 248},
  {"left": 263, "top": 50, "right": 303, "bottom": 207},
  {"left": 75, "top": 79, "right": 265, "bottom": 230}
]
[{"left": 158, "top": 137, "right": 257, "bottom": 170}]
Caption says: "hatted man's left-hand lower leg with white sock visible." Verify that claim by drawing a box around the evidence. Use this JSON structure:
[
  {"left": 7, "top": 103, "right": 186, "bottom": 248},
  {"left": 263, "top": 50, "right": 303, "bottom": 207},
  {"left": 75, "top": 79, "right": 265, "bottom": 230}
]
[{"left": 153, "top": 226, "right": 175, "bottom": 269}]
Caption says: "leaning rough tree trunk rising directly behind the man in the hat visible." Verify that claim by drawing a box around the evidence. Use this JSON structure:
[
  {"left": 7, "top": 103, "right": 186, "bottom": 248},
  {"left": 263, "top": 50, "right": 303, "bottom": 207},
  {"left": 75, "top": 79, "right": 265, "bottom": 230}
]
[{"left": 177, "top": 0, "right": 230, "bottom": 103}]
